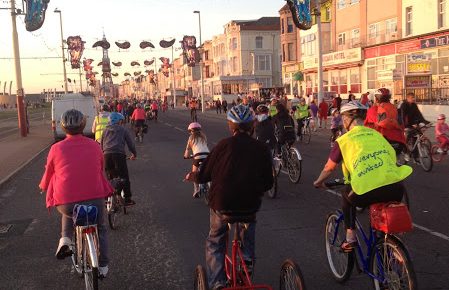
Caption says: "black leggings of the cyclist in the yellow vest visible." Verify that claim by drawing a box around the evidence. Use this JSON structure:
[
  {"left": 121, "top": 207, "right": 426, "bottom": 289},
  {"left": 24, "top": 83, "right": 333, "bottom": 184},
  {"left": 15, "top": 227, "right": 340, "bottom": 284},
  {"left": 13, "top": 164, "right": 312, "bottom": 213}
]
[{"left": 342, "top": 182, "right": 405, "bottom": 229}]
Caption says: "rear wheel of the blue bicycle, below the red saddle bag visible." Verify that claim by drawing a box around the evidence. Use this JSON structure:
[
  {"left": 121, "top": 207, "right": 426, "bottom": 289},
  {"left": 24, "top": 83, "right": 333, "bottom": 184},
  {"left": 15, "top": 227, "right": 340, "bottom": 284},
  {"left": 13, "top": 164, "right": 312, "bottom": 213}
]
[{"left": 370, "top": 235, "right": 418, "bottom": 290}]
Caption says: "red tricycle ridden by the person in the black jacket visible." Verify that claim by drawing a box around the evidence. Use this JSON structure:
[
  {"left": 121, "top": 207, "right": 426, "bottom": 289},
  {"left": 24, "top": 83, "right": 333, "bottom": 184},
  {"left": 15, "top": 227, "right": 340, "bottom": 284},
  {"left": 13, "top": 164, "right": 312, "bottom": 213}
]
[{"left": 194, "top": 215, "right": 306, "bottom": 290}]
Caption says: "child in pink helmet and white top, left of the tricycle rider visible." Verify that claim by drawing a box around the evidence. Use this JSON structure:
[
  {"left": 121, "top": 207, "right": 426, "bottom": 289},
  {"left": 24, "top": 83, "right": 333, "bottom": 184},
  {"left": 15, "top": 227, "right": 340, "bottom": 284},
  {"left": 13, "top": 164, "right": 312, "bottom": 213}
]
[{"left": 184, "top": 122, "right": 209, "bottom": 198}]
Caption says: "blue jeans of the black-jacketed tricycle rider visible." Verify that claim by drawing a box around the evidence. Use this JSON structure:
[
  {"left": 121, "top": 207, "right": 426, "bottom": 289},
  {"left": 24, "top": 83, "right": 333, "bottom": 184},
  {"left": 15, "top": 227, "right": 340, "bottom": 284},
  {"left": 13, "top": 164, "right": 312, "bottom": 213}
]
[{"left": 206, "top": 209, "right": 256, "bottom": 289}]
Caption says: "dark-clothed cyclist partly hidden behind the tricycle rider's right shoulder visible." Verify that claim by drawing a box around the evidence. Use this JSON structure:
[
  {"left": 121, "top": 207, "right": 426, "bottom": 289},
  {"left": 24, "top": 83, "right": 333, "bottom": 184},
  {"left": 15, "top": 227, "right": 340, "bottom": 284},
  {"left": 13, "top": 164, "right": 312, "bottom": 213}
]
[{"left": 254, "top": 105, "right": 276, "bottom": 150}]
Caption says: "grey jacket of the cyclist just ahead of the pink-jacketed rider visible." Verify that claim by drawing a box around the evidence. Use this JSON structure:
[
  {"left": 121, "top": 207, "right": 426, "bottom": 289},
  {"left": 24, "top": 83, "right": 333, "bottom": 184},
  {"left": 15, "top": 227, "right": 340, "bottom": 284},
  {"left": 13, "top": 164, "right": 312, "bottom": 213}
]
[{"left": 101, "top": 125, "right": 137, "bottom": 156}]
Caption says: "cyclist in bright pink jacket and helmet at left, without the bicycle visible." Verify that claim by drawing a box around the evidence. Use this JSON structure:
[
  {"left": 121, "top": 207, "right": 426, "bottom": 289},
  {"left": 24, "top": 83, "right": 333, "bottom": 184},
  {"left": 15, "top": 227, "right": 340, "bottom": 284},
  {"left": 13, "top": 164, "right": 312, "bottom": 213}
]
[{"left": 39, "top": 109, "right": 114, "bottom": 276}]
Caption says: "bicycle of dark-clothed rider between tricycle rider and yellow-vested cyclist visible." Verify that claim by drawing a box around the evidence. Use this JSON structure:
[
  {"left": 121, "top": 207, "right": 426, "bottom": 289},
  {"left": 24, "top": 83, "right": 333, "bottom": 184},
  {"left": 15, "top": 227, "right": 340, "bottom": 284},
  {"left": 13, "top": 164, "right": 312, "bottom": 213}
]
[{"left": 275, "top": 142, "right": 302, "bottom": 184}]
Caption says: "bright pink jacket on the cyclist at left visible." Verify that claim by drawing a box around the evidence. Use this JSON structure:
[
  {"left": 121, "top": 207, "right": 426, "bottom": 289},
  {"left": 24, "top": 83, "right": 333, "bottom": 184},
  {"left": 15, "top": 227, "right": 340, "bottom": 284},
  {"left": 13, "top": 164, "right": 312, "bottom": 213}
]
[{"left": 39, "top": 135, "right": 114, "bottom": 208}]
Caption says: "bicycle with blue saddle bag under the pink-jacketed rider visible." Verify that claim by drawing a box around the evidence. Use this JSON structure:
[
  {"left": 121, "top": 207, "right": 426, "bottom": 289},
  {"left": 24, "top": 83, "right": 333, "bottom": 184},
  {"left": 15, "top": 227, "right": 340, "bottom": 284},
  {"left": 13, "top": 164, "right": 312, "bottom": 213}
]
[{"left": 71, "top": 205, "right": 100, "bottom": 290}]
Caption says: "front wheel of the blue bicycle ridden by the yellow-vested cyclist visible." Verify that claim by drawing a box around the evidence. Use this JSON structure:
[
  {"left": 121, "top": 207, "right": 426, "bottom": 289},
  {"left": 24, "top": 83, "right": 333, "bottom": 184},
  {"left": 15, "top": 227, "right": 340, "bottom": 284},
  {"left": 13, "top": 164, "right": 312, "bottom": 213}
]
[{"left": 324, "top": 213, "right": 354, "bottom": 283}]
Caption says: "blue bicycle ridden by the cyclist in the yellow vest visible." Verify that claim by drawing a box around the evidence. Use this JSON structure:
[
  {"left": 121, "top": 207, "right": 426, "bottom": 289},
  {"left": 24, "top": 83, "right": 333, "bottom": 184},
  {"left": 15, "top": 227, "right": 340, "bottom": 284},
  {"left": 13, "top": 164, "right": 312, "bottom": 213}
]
[{"left": 325, "top": 181, "right": 418, "bottom": 290}]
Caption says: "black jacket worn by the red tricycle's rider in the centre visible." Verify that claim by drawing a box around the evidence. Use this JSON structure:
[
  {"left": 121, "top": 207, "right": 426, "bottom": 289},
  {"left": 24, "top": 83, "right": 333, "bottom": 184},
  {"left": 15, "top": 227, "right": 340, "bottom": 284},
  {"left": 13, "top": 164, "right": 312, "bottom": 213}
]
[{"left": 197, "top": 133, "right": 273, "bottom": 212}]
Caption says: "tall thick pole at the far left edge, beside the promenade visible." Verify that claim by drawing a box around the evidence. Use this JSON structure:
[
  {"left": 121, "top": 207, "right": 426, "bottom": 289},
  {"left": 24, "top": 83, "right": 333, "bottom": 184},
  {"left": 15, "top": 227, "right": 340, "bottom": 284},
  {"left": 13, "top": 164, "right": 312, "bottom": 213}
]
[{"left": 11, "top": 0, "right": 28, "bottom": 137}]
